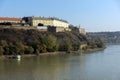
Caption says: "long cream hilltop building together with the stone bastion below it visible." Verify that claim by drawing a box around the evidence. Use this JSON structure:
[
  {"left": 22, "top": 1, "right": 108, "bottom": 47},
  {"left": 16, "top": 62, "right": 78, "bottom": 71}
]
[{"left": 22, "top": 17, "right": 70, "bottom": 32}]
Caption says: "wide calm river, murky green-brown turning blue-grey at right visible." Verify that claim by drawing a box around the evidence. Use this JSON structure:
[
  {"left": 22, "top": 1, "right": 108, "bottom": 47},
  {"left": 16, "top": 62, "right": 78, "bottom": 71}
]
[{"left": 0, "top": 45, "right": 120, "bottom": 80}]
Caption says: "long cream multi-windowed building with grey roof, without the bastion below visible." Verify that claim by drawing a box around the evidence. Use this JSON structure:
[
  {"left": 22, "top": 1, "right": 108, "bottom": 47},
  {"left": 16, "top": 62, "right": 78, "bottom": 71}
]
[{"left": 23, "top": 17, "right": 69, "bottom": 30}]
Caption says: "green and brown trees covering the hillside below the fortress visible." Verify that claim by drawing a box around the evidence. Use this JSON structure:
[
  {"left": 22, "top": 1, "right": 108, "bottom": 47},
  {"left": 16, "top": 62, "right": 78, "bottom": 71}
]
[{"left": 0, "top": 28, "right": 102, "bottom": 55}]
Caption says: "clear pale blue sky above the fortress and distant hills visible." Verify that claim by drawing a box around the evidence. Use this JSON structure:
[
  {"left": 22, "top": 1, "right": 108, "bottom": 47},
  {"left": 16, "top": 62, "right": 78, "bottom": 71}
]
[{"left": 0, "top": 0, "right": 120, "bottom": 32}]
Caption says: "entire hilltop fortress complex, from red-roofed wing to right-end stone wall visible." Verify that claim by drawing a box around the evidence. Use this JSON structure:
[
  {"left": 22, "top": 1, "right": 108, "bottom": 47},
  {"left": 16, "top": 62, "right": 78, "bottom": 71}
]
[{"left": 0, "top": 16, "right": 86, "bottom": 35}]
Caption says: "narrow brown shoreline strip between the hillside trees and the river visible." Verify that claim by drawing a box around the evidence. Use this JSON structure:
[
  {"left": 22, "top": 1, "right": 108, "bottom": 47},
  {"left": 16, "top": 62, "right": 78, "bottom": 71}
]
[{"left": 0, "top": 48, "right": 105, "bottom": 60}]
